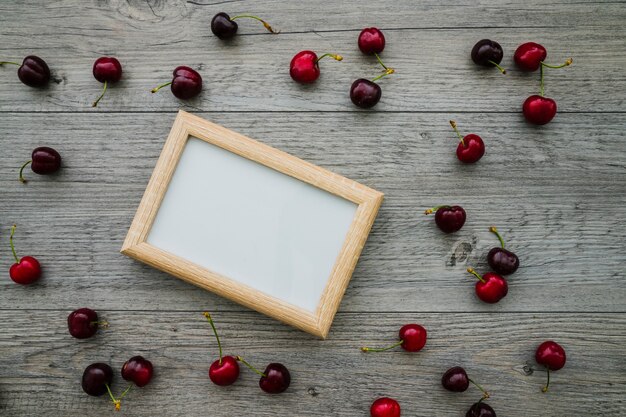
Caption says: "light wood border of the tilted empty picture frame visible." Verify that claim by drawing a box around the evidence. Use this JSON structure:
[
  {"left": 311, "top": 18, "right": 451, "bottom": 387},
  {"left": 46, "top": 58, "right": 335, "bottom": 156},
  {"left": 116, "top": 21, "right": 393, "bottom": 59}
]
[{"left": 121, "top": 110, "right": 383, "bottom": 339}]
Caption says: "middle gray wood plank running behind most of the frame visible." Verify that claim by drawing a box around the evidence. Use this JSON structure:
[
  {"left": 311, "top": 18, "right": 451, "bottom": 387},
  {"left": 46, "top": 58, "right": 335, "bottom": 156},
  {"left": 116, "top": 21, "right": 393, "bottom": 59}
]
[{"left": 0, "top": 113, "right": 626, "bottom": 311}]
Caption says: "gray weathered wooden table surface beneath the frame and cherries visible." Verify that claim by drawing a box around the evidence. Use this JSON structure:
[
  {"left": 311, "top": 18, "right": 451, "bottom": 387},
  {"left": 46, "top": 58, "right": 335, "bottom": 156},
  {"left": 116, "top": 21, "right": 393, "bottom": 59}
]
[{"left": 0, "top": 0, "right": 626, "bottom": 417}]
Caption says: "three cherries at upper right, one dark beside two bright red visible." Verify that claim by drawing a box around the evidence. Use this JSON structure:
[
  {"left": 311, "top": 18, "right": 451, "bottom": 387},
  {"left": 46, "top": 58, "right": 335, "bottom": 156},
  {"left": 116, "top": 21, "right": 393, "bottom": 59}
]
[{"left": 471, "top": 39, "right": 572, "bottom": 125}]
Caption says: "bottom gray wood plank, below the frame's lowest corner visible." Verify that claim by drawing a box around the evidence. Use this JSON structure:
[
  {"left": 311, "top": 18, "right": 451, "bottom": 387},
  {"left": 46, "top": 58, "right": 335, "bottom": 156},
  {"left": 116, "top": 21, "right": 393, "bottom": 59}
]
[{"left": 0, "top": 306, "right": 626, "bottom": 417}]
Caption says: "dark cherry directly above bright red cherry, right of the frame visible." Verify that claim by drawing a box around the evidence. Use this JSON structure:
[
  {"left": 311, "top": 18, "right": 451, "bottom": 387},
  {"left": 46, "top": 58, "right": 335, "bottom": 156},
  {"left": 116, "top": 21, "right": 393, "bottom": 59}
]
[{"left": 467, "top": 226, "right": 519, "bottom": 304}]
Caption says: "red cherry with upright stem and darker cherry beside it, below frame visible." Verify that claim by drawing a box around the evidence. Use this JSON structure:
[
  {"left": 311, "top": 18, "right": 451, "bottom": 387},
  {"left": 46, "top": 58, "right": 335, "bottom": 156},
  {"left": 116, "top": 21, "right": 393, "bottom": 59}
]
[{"left": 204, "top": 312, "right": 291, "bottom": 394}]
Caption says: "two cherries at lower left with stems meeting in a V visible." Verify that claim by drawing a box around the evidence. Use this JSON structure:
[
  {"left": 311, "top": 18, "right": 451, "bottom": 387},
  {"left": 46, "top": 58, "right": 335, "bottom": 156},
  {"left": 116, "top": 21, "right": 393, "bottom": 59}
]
[{"left": 81, "top": 356, "right": 154, "bottom": 410}]
